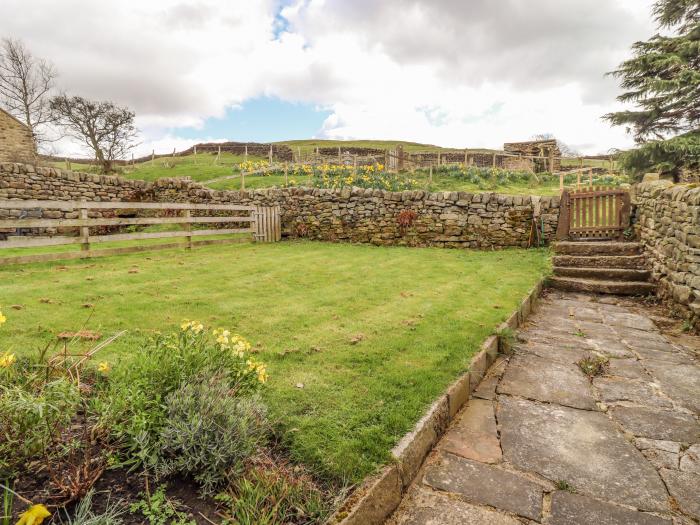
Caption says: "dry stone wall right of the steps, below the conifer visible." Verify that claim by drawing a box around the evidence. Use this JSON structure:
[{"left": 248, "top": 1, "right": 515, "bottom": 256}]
[{"left": 633, "top": 181, "right": 700, "bottom": 326}]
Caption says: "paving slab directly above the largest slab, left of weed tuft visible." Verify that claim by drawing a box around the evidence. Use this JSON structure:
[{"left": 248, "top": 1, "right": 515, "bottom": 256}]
[{"left": 496, "top": 355, "right": 596, "bottom": 410}]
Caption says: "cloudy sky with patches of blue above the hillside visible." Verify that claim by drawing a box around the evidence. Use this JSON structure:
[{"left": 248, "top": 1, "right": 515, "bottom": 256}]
[{"left": 0, "top": 0, "right": 656, "bottom": 155}]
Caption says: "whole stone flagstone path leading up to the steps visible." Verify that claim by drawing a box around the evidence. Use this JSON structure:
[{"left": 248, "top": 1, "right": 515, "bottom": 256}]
[{"left": 387, "top": 293, "right": 700, "bottom": 525}]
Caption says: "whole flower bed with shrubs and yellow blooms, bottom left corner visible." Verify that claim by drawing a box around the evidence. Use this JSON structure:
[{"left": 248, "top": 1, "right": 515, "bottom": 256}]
[{"left": 0, "top": 312, "right": 328, "bottom": 525}]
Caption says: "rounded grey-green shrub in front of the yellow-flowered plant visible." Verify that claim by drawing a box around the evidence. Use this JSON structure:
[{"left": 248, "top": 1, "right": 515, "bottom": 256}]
[{"left": 158, "top": 376, "right": 268, "bottom": 493}]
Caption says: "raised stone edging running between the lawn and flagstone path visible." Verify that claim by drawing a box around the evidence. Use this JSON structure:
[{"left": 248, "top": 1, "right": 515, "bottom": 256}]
[{"left": 328, "top": 279, "right": 544, "bottom": 525}]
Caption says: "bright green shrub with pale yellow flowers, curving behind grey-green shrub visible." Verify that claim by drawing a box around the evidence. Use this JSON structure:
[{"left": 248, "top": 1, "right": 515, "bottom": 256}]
[{"left": 97, "top": 321, "right": 267, "bottom": 469}]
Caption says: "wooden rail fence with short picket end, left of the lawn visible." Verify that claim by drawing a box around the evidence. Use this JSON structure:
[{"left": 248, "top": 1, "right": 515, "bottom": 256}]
[{"left": 0, "top": 200, "right": 281, "bottom": 264}]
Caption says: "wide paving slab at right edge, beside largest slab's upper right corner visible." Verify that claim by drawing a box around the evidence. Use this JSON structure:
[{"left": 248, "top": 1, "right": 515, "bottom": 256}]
[{"left": 610, "top": 406, "right": 700, "bottom": 443}]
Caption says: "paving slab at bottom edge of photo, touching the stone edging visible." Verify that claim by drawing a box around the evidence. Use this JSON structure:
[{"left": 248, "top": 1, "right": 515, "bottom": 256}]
[{"left": 387, "top": 485, "right": 522, "bottom": 525}]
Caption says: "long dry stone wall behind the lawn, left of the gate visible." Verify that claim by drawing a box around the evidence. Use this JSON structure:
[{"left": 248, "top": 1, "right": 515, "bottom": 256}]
[{"left": 0, "top": 164, "right": 559, "bottom": 248}]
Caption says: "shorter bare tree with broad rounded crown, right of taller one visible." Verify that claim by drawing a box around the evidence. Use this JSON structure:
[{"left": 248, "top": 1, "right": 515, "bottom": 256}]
[{"left": 50, "top": 95, "right": 138, "bottom": 173}]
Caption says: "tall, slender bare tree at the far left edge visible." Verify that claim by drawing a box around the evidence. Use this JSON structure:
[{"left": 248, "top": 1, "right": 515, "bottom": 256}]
[{"left": 0, "top": 38, "right": 57, "bottom": 146}]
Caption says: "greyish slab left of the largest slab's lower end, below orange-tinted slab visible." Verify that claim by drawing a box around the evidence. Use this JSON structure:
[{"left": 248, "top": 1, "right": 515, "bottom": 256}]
[{"left": 423, "top": 454, "right": 544, "bottom": 520}]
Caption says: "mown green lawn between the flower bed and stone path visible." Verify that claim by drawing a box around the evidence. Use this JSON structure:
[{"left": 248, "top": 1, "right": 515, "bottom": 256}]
[{"left": 0, "top": 242, "right": 548, "bottom": 482}]
